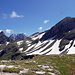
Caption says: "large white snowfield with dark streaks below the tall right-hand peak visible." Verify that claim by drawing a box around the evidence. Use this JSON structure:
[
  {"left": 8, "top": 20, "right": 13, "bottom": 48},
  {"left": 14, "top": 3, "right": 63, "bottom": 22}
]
[{"left": 24, "top": 40, "right": 75, "bottom": 55}]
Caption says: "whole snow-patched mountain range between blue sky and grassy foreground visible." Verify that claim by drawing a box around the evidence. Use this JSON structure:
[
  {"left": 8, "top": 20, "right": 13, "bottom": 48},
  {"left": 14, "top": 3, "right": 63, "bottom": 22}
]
[{"left": 0, "top": 17, "right": 75, "bottom": 60}]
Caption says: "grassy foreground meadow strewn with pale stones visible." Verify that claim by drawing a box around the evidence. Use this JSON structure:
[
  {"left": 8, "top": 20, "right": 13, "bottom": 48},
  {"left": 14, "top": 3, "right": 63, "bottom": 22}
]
[{"left": 0, "top": 55, "right": 75, "bottom": 75}]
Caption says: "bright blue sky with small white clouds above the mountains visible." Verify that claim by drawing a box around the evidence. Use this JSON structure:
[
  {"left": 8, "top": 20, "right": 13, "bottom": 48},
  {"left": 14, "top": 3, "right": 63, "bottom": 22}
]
[{"left": 0, "top": 0, "right": 75, "bottom": 36}]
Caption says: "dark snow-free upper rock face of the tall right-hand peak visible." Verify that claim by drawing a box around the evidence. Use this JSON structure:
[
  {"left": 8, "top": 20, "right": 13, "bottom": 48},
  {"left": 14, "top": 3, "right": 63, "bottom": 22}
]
[{"left": 41, "top": 17, "right": 75, "bottom": 40}]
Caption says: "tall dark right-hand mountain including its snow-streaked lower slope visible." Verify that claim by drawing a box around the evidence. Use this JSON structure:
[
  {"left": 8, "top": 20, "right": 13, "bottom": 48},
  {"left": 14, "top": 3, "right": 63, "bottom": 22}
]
[{"left": 24, "top": 17, "right": 75, "bottom": 55}]
